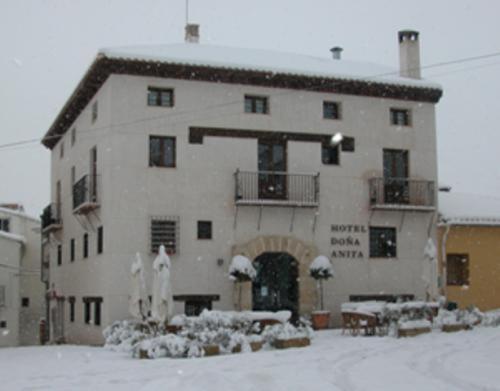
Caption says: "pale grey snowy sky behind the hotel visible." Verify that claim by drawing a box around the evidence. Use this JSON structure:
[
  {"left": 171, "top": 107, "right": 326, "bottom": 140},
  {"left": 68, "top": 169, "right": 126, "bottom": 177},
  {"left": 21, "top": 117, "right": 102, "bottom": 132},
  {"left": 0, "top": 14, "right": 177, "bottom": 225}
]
[{"left": 0, "top": 0, "right": 500, "bottom": 215}]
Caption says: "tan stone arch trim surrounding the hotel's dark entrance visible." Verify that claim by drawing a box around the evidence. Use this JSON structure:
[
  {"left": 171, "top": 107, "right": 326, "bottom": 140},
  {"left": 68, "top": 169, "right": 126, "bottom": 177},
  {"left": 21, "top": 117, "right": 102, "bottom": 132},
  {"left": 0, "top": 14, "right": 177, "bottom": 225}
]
[{"left": 231, "top": 235, "right": 318, "bottom": 315}]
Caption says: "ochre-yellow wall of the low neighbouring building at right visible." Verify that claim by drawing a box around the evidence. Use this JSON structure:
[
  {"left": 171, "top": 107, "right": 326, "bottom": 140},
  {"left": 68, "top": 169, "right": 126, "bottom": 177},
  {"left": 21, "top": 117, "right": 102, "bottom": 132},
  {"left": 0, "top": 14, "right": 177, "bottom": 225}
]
[{"left": 439, "top": 226, "right": 500, "bottom": 311}]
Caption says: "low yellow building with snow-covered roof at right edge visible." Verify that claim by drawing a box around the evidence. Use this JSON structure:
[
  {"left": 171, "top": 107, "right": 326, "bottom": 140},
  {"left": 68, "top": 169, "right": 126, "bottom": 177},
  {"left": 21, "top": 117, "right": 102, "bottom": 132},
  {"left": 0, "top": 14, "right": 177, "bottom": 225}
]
[{"left": 438, "top": 192, "right": 500, "bottom": 311}]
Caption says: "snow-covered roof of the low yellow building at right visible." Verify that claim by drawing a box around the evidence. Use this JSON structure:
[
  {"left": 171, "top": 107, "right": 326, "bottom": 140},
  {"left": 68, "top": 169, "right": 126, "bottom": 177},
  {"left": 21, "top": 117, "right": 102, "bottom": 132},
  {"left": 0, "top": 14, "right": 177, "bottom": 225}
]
[{"left": 439, "top": 191, "right": 500, "bottom": 226}]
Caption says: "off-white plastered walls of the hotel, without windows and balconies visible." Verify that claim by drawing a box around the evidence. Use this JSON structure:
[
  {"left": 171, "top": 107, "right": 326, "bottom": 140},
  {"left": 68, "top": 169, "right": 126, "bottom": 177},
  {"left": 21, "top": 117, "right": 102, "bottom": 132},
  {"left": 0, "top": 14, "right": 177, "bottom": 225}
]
[{"left": 46, "top": 75, "right": 437, "bottom": 343}]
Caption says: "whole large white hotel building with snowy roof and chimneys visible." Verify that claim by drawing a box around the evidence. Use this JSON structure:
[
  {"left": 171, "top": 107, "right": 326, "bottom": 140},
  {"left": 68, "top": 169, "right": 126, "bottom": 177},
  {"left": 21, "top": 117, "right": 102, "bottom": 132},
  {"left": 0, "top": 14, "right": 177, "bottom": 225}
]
[{"left": 43, "top": 25, "right": 442, "bottom": 343}]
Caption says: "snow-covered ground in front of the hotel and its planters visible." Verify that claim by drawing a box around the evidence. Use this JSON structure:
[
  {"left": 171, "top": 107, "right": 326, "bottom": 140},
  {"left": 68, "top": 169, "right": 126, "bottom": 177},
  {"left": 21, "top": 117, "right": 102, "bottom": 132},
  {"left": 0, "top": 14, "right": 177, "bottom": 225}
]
[{"left": 0, "top": 327, "right": 500, "bottom": 391}]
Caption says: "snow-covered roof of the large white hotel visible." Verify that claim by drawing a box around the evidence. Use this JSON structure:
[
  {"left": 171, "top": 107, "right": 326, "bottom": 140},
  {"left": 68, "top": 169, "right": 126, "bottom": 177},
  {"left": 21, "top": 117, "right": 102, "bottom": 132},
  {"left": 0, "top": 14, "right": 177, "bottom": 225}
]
[{"left": 99, "top": 43, "right": 441, "bottom": 89}]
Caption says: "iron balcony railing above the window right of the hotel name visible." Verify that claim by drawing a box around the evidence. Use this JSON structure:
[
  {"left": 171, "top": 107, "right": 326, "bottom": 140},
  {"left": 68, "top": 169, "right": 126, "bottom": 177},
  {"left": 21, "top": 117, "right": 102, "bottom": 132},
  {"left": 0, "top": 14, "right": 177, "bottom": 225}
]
[{"left": 369, "top": 178, "right": 435, "bottom": 211}]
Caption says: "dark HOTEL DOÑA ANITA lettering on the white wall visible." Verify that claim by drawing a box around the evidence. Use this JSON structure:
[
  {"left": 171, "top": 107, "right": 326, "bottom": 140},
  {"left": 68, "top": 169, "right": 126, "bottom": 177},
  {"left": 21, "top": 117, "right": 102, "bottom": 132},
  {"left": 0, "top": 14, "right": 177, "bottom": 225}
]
[{"left": 330, "top": 224, "right": 368, "bottom": 259}]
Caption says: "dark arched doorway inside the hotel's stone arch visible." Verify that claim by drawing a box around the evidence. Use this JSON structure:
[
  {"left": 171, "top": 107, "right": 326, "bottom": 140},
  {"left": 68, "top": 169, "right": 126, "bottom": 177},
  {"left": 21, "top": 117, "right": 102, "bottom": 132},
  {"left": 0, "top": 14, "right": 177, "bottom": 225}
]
[{"left": 252, "top": 252, "right": 299, "bottom": 319}]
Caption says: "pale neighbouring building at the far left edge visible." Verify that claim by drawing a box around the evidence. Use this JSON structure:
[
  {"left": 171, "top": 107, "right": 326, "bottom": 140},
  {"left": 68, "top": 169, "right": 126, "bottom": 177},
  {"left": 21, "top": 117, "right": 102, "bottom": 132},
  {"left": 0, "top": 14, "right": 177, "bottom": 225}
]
[{"left": 0, "top": 204, "right": 45, "bottom": 347}]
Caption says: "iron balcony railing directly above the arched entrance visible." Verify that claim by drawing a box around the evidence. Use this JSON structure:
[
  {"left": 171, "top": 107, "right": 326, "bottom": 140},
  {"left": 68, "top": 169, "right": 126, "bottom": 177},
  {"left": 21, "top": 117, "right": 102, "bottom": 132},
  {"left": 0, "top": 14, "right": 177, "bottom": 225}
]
[{"left": 234, "top": 170, "right": 319, "bottom": 207}]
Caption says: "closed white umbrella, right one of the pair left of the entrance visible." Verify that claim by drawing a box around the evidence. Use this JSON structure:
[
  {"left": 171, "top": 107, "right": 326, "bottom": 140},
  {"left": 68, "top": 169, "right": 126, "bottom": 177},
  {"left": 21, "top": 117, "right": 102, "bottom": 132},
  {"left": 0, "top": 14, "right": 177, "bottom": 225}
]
[{"left": 151, "top": 245, "right": 174, "bottom": 323}]
